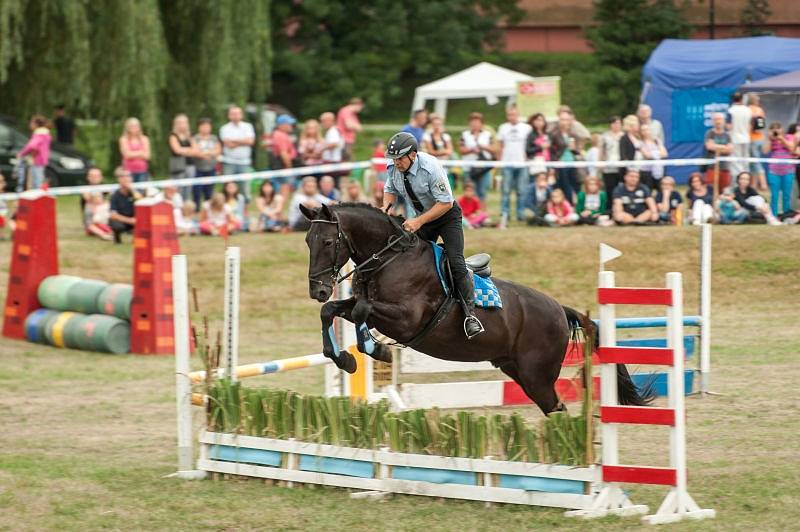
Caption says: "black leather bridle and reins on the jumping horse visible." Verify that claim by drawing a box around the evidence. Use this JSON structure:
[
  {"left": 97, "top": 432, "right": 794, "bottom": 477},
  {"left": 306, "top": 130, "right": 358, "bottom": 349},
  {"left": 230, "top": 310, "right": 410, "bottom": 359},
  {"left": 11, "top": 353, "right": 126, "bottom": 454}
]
[{"left": 308, "top": 212, "right": 419, "bottom": 288}]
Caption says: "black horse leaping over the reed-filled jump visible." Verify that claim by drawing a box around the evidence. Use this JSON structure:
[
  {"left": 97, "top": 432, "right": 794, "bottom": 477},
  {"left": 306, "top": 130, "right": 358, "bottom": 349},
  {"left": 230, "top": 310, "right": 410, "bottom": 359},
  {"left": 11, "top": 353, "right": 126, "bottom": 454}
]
[{"left": 301, "top": 204, "right": 649, "bottom": 414}]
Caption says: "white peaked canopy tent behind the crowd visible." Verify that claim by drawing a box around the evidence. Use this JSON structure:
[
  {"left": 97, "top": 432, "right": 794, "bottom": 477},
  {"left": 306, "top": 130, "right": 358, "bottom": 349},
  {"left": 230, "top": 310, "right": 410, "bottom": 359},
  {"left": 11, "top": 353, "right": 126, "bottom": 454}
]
[{"left": 411, "top": 62, "right": 533, "bottom": 116}]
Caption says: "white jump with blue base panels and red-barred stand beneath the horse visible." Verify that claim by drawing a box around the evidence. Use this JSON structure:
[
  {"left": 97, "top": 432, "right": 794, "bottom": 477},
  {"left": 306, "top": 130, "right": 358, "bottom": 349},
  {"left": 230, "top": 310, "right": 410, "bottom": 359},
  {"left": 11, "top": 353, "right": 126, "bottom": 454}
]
[{"left": 173, "top": 255, "right": 715, "bottom": 524}]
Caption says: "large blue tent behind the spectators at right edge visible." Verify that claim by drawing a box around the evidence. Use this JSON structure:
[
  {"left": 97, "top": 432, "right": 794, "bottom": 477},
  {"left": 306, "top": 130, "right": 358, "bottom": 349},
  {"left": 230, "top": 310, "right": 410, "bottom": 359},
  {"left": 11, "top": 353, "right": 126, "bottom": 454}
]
[{"left": 642, "top": 37, "right": 800, "bottom": 181}]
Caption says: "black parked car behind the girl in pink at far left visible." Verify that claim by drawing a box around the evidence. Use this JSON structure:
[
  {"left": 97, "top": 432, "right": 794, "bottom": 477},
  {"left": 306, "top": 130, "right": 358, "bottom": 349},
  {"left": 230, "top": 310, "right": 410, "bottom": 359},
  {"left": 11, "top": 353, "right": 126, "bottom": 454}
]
[{"left": 0, "top": 116, "right": 94, "bottom": 192}]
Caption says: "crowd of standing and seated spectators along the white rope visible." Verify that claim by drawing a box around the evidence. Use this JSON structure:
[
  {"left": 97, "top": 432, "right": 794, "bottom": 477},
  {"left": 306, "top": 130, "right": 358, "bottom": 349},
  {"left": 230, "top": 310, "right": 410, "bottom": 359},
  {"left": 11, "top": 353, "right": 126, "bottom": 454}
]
[{"left": 0, "top": 93, "right": 800, "bottom": 247}]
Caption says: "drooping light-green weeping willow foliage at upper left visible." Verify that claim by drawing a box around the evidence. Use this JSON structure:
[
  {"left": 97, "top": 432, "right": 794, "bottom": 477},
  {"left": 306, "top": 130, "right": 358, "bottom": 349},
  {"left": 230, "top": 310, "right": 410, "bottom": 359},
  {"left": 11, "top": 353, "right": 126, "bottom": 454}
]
[{"left": 0, "top": 0, "right": 272, "bottom": 172}]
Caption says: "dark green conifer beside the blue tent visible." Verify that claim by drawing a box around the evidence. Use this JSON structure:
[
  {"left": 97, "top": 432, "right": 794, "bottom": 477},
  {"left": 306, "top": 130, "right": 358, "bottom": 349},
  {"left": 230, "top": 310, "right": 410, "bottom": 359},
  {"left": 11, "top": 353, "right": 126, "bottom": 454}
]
[{"left": 587, "top": 0, "right": 691, "bottom": 115}]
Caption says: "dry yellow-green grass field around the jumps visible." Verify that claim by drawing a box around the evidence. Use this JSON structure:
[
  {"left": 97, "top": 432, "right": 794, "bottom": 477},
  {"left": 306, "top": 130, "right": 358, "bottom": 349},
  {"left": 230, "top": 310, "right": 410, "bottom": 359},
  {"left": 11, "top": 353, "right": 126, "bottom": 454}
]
[{"left": 0, "top": 199, "right": 800, "bottom": 531}]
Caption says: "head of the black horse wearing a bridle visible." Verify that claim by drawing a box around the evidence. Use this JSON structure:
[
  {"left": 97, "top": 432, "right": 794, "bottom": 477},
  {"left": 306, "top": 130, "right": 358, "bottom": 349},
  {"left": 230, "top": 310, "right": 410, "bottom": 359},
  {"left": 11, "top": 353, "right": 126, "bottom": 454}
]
[{"left": 300, "top": 205, "right": 350, "bottom": 303}]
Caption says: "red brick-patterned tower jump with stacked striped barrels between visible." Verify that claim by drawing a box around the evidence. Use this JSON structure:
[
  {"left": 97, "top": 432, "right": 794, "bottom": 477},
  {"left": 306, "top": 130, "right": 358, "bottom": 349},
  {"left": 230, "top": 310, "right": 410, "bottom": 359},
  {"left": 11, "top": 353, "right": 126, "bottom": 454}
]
[{"left": 3, "top": 190, "right": 178, "bottom": 354}]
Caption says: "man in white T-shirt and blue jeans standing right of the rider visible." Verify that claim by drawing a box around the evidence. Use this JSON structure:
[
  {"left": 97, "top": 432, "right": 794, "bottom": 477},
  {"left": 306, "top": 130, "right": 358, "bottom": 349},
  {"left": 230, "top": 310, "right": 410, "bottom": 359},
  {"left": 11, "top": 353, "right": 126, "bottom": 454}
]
[{"left": 497, "top": 107, "right": 532, "bottom": 227}]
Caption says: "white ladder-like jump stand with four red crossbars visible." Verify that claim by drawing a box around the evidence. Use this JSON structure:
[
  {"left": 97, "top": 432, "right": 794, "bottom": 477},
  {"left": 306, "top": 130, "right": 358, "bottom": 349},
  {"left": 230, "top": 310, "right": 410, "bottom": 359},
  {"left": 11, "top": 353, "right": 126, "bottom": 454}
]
[{"left": 566, "top": 271, "right": 715, "bottom": 524}]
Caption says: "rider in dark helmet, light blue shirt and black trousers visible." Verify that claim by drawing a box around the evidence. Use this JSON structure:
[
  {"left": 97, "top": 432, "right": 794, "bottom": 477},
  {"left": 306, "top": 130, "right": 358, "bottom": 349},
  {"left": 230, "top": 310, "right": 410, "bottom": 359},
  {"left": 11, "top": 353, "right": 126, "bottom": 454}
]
[{"left": 383, "top": 132, "right": 483, "bottom": 338}]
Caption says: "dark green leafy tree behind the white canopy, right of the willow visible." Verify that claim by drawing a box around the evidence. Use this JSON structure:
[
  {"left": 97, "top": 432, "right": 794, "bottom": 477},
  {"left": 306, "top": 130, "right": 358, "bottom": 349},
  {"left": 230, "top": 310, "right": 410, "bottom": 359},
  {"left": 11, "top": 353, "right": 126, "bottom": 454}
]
[{"left": 272, "top": 0, "right": 522, "bottom": 116}]
